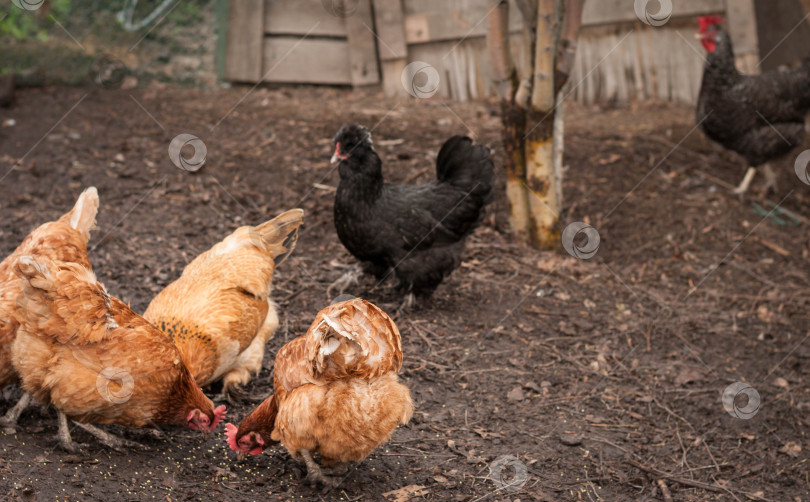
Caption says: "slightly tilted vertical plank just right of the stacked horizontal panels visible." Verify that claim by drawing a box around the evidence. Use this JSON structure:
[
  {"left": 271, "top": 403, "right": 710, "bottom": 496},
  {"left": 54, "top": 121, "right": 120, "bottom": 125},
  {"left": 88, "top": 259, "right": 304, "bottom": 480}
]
[{"left": 346, "top": 0, "right": 380, "bottom": 85}]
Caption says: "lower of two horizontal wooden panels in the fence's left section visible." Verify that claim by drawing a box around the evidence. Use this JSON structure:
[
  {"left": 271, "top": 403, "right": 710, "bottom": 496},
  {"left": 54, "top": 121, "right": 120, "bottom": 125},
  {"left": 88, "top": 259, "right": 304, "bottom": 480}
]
[{"left": 263, "top": 37, "right": 352, "bottom": 84}]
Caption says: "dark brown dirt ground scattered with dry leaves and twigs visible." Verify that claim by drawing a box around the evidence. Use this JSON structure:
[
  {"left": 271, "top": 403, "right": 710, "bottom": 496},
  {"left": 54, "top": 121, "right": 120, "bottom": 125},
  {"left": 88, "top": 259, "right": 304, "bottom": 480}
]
[{"left": 0, "top": 87, "right": 810, "bottom": 502}]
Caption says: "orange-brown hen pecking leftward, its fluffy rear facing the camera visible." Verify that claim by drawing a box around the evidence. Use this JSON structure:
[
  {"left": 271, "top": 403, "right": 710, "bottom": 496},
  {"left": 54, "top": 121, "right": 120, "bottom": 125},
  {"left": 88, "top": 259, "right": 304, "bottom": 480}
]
[{"left": 225, "top": 298, "right": 413, "bottom": 486}]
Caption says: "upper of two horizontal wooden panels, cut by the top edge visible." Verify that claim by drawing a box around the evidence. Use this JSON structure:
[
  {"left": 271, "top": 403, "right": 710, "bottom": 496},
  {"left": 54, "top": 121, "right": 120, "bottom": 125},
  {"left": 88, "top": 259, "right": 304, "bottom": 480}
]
[{"left": 259, "top": 0, "right": 344, "bottom": 37}]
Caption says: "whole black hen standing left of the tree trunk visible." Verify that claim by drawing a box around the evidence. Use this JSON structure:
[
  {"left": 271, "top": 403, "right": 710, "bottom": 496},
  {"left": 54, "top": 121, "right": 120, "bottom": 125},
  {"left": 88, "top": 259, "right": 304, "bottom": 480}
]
[{"left": 330, "top": 125, "right": 494, "bottom": 307}]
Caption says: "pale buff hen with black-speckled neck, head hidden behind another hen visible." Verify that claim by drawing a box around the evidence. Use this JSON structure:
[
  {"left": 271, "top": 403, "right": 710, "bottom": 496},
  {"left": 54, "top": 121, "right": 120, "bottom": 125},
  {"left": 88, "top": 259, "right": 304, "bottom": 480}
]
[{"left": 144, "top": 209, "right": 304, "bottom": 401}]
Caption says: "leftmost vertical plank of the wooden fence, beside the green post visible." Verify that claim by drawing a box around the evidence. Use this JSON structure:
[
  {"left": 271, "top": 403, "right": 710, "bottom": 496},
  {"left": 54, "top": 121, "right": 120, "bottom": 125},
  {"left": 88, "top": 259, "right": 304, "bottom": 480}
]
[{"left": 225, "top": 0, "right": 264, "bottom": 82}]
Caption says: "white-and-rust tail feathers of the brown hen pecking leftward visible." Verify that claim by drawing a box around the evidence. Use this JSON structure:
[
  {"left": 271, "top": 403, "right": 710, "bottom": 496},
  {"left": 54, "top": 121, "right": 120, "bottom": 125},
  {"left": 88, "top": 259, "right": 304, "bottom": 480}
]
[{"left": 305, "top": 298, "right": 402, "bottom": 380}]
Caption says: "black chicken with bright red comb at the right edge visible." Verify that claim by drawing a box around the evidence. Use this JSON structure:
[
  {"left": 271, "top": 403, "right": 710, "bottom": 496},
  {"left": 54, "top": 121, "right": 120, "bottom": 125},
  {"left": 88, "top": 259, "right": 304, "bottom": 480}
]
[{"left": 697, "top": 16, "right": 810, "bottom": 194}]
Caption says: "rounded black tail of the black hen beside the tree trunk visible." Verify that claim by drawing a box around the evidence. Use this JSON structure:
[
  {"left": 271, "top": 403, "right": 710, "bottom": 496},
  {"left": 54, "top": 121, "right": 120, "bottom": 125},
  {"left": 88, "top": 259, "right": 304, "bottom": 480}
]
[{"left": 436, "top": 136, "right": 495, "bottom": 204}]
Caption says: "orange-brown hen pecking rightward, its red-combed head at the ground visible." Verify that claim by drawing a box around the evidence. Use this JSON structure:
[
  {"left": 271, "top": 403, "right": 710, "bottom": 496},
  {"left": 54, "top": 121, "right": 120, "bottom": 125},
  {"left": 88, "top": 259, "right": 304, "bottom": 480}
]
[{"left": 11, "top": 255, "right": 225, "bottom": 451}]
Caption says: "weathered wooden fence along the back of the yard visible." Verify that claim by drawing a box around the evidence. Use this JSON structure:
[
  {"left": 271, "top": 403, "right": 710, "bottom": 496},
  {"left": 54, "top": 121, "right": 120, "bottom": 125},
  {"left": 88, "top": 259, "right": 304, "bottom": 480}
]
[{"left": 225, "top": 0, "right": 810, "bottom": 104}]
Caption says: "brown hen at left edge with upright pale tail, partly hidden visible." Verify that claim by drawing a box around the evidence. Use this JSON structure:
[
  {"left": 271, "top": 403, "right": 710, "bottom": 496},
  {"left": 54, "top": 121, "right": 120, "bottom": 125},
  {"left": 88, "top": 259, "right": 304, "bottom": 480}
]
[{"left": 0, "top": 187, "right": 98, "bottom": 433}]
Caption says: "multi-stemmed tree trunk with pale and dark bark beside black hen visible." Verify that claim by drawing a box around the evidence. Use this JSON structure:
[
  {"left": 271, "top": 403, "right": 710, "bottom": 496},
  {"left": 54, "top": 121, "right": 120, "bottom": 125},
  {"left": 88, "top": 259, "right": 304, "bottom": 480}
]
[{"left": 487, "top": 0, "right": 585, "bottom": 249}]
